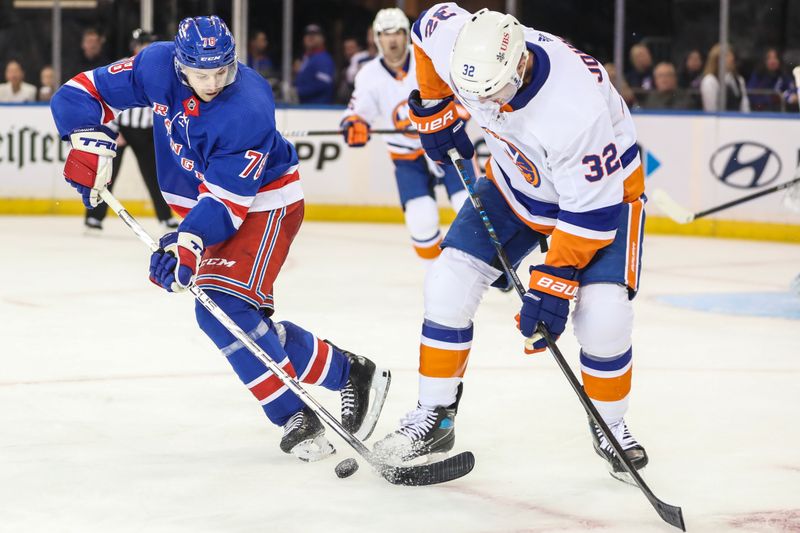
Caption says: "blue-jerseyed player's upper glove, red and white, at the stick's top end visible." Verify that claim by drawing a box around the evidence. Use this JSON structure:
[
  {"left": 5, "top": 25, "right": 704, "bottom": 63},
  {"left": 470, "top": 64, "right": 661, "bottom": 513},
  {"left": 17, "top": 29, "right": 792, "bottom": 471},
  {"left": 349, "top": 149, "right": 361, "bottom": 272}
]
[{"left": 64, "top": 126, "right": 117, "bottom": 208}]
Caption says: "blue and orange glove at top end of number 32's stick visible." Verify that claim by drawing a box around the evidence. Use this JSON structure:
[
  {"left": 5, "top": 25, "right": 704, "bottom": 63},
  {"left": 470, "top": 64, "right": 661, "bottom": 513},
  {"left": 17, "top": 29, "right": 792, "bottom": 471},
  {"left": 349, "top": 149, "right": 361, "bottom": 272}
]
[{"left": 408, "top": 90, "right": 475, "bottom": 165}]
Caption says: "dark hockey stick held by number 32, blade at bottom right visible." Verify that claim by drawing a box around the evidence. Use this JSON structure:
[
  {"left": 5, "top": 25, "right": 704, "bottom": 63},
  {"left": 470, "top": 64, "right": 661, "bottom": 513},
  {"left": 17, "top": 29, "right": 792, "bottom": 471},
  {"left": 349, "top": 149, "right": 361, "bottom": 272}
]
[{"left": 448, "top": 149, "right": 686, "bottom": 531}]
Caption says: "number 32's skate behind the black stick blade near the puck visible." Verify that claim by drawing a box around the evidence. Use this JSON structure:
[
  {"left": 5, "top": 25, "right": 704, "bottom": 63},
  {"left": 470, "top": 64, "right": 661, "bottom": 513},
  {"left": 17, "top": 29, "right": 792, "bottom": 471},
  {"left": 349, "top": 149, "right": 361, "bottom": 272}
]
[{"left": 374, "top": 383, "right": 463, "bottom": 463}]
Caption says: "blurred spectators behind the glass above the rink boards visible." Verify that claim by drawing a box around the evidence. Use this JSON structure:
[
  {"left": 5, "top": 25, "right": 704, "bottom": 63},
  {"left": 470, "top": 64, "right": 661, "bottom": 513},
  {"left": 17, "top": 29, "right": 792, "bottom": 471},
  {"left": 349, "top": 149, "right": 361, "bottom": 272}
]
[{"left": 0, "top": 13, "right": 798, "bottom": 112}]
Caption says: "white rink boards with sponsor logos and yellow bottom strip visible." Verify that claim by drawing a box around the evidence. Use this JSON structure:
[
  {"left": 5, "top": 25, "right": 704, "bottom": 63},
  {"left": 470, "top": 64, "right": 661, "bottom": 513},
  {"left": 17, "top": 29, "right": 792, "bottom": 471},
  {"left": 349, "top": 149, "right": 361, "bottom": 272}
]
[{"left": 0, "top": 105, "right": 800, "bottom": 242}]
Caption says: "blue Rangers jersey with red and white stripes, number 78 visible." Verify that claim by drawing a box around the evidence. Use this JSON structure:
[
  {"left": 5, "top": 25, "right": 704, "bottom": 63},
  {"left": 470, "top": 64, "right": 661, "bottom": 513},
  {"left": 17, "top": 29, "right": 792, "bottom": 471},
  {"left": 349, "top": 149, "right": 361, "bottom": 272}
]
[{"left": 50, "top": 42, "right": 303, "bottom": 246}]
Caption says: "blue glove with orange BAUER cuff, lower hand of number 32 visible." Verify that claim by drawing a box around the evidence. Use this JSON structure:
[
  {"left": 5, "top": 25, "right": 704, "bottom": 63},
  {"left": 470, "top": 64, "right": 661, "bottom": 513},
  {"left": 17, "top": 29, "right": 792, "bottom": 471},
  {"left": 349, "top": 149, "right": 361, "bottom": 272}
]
[{"left": 519, "top": 265, "right": 578, "bottom": 353}]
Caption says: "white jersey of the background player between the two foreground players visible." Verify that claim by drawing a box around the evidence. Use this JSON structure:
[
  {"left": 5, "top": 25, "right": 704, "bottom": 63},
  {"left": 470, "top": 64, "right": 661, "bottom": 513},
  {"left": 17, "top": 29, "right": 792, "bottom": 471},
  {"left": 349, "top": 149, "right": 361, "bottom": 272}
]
[{"left": 344, "top": 51, "right": 425, "bottom": 159}]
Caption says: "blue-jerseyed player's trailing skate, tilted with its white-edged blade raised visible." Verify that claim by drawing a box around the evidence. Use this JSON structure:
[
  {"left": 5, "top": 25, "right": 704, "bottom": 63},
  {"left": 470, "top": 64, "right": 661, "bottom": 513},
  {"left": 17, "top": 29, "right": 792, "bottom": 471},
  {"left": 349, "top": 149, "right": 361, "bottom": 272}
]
[{"left": 325, "top": 340, "right": 392, "bottom": 441}]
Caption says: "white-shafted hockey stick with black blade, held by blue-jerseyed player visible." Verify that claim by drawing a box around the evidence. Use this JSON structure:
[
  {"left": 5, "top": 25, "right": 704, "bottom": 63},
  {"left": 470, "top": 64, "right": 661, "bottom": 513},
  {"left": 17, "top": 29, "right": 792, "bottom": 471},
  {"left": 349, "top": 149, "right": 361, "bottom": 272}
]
[{"left": 100, "top": 189, "right": 475, "bottom": 486}]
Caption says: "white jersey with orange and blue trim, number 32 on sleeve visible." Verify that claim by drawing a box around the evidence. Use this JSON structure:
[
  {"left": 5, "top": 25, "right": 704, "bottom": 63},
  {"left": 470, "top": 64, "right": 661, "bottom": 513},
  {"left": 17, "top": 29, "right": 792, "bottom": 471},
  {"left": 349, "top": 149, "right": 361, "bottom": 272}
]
[{"left": 412, "top": 2, "right": 644, "bottom": 268}]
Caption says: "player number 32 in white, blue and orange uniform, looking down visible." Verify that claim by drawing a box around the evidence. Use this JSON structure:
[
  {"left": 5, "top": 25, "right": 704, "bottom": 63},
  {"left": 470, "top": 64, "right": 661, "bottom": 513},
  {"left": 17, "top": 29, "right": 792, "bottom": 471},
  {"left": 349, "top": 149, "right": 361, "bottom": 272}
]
[{"left": 376, "top": 3, "right": 648, "bottom": 475}]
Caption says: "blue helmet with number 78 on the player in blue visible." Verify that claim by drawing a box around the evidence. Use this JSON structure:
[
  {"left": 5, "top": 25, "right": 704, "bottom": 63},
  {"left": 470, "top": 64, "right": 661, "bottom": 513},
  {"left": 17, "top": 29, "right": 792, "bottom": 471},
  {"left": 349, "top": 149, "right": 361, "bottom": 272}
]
[{"left": 175, "top": 15, "right": 237, "bottom": 91}]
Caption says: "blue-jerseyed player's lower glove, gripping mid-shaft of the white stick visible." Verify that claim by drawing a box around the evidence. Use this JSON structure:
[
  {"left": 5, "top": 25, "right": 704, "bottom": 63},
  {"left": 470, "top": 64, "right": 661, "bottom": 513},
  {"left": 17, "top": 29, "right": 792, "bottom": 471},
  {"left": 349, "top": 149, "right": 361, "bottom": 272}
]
[{"left": 150, "top": 231, "right": 203, "bottom": 292}]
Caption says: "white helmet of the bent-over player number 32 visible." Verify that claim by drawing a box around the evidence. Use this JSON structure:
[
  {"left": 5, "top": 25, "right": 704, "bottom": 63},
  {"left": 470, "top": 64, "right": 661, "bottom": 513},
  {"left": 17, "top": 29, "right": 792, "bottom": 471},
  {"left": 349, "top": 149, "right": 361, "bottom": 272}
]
[{"left": 450, "top": 8, "right": 528, "bottom": 105}]
